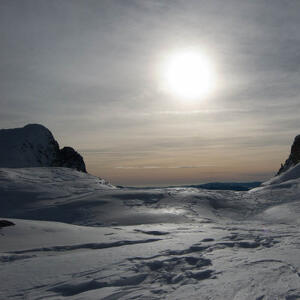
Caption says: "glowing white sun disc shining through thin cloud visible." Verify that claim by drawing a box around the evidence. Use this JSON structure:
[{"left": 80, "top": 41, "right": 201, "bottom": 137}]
[{"left": 163, "top": 51, "right": 215, "bottom": 99}]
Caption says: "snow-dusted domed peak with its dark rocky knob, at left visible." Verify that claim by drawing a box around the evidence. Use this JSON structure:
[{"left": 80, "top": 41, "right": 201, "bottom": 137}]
[{"left": 0, "top": 124, "right": 86, "bottom": 172}]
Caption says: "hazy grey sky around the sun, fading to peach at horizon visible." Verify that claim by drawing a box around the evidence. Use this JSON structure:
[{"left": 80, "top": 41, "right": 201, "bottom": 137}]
[{"left": 0, "top": 0, "right": 300, "bottom": 185}]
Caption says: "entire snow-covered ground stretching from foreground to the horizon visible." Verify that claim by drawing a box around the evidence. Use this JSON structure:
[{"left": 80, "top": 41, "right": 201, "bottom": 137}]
[{"left": 0, "top": 165, "right": 300, "bottom": 300}]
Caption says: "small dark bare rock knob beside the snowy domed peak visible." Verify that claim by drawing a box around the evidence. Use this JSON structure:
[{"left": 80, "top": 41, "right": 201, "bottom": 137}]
[{"left": 57, "top": 147, "right": 86, "bottom": 173}]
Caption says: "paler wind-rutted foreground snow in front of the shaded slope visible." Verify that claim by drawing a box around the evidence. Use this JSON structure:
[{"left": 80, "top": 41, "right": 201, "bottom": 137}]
[{"left": 0, "top": 219, "right": 300, "bottom": 299}]
